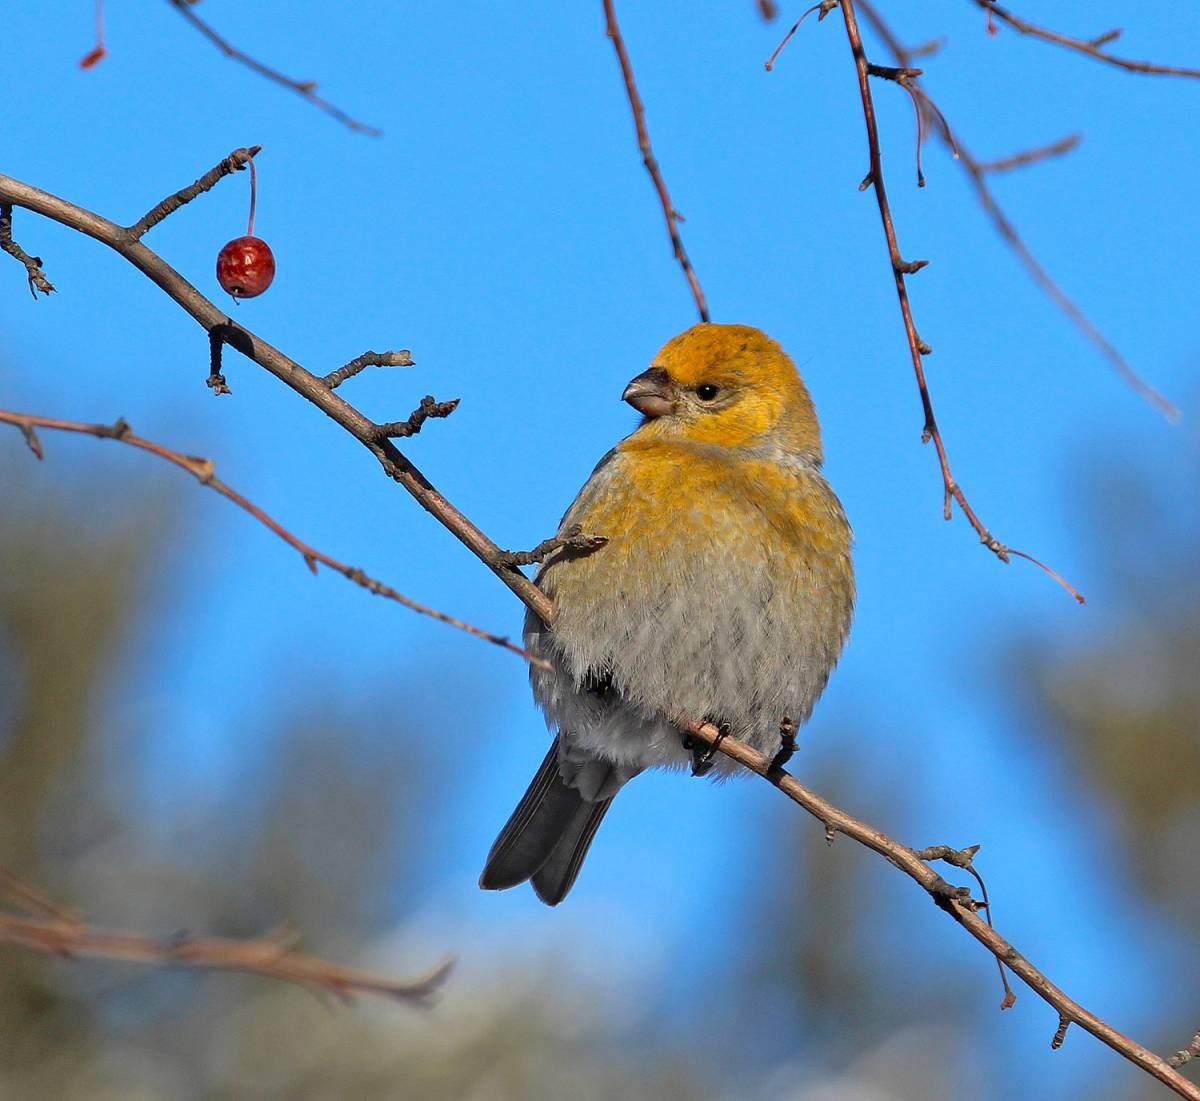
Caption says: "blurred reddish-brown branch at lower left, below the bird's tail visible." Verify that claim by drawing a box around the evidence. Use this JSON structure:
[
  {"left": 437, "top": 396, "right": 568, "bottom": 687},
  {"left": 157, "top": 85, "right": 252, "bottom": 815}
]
[{"left": 0, "top": 868, "right": 452, "bottom": 1005}]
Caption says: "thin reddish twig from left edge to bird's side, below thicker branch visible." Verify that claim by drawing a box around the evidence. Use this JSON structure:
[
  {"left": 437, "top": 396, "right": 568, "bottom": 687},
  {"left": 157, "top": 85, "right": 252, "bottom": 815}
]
[{"left": 0, "top": 409, "right": 551, "bottom": 672}]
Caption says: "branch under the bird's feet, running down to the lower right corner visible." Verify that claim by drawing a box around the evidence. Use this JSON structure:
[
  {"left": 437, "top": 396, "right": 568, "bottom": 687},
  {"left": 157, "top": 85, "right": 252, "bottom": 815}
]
[{"left": 677, "top": 719, "right": 1200, "bottom": 1101}]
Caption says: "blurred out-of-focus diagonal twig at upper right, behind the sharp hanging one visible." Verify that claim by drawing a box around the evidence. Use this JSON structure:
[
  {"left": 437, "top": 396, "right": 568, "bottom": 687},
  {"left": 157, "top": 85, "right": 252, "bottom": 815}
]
[{"left": 858, "top": 0, "right": 1181, "bottom": 423}]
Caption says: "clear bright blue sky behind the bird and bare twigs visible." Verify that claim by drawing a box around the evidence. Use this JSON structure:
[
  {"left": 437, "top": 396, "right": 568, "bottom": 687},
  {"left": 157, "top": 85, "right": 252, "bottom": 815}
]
[{"left": 0, "top": 0, "right": 1200, "bottom": 1090}]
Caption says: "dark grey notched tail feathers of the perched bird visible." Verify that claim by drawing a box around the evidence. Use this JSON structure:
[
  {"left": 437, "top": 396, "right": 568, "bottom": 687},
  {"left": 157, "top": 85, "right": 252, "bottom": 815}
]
[{"left": 479, "top": 738, "right": 628, "bottom": 906}]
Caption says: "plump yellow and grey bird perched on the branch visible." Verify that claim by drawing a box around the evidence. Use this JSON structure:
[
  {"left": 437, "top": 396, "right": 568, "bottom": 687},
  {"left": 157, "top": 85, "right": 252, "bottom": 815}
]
[{"left": 479, "top": 323, "right": 854, "bottom": 906}]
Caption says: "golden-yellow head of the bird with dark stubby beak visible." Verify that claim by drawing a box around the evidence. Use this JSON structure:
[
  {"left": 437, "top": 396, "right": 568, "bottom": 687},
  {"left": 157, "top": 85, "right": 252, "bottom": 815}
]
[{"left": 622, "top": 324, "right": 821, "bottom": 463}]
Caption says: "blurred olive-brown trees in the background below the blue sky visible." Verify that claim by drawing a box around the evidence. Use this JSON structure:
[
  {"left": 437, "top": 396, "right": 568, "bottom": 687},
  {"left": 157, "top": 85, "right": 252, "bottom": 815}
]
[{"left": 0, "top": 440, "right": 1200, "bottom": 1101}]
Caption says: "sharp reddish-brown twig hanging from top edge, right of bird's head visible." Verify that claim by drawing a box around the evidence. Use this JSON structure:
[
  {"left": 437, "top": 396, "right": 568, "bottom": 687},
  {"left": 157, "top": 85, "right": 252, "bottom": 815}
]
[{"left": 840, "top": 0, "right": 1084, "bottom": 603}]
